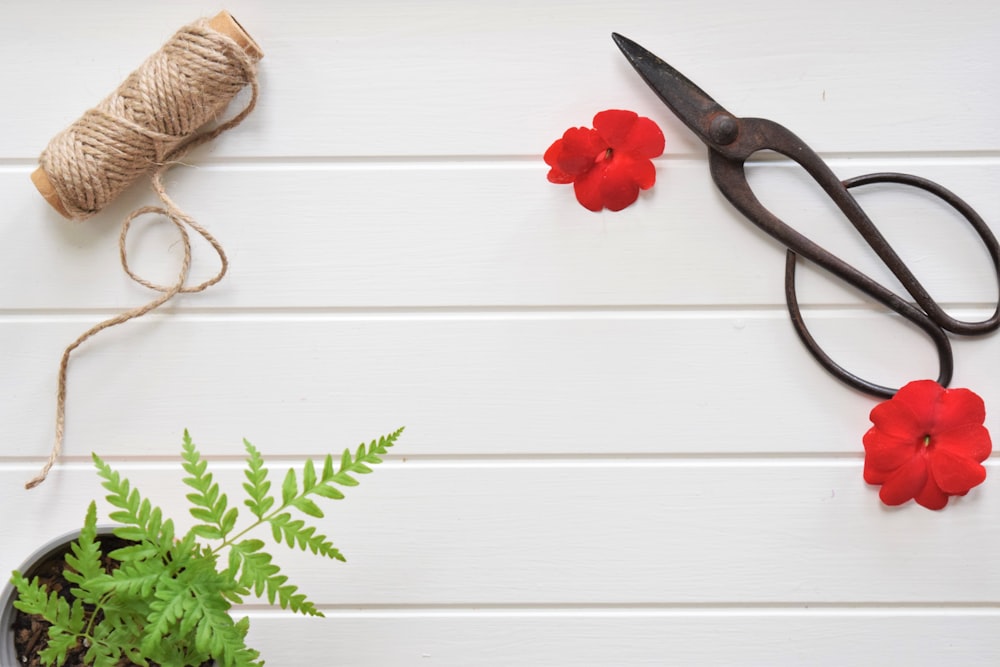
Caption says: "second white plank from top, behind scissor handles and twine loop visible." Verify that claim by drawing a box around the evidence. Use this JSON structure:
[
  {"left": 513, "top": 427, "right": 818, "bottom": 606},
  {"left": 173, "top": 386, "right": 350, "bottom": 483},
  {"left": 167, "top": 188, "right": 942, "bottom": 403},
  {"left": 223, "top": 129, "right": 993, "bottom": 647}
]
[{"left": 0, "top": 159, "right": 1000, "bottom": 311}]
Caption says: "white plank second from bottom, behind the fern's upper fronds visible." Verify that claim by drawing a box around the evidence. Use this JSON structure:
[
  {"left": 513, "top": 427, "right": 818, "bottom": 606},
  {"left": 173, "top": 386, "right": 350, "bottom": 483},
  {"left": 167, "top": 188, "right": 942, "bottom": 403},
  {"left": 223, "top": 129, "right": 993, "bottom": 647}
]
[{"left": 0, "top": 462, "right": 1000, "bottom": 609}]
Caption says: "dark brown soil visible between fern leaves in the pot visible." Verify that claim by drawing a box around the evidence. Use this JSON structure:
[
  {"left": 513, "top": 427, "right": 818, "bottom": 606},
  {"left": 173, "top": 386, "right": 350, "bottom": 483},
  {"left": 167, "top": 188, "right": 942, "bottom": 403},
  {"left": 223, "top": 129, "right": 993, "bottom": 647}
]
[{"left": 12, "top": 535, "right": 212, "bottom": 667}]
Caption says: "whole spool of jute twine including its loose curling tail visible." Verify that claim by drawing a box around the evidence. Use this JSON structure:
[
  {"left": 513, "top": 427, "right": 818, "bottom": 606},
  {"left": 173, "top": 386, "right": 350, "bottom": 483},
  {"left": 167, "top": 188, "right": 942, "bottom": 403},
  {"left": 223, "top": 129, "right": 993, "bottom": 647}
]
[{"left": 25, "top": 12, "right": 263, "bottom": 489}]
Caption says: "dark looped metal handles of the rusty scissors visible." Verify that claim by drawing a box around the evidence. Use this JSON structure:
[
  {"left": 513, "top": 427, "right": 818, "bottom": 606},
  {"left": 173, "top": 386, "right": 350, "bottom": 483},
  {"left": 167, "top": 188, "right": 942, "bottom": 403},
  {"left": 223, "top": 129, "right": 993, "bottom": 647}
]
[{"left": 709, "top": 118, "right": 988, "bottom": 397}]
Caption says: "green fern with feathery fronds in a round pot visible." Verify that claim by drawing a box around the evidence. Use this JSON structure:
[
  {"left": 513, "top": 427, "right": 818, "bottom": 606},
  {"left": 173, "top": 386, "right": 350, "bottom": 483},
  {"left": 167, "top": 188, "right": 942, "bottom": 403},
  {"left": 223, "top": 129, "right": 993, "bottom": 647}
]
[{"left": 0, "top": 429, "right": 402, "bottom": 667}]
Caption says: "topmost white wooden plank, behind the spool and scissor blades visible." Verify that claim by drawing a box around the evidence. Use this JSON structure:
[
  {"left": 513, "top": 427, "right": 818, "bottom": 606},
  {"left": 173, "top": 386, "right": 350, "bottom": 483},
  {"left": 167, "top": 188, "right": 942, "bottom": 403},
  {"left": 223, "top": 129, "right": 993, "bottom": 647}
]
[{"left": 0, "top": 0, "right": 1000, "bottom": 159}]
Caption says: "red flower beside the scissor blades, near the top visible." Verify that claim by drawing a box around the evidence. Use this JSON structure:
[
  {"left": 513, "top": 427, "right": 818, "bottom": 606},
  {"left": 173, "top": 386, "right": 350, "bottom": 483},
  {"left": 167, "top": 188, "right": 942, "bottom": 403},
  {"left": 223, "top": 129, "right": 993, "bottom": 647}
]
[{"left": 545, "top": 109, "right": 663, "bottom": 211}]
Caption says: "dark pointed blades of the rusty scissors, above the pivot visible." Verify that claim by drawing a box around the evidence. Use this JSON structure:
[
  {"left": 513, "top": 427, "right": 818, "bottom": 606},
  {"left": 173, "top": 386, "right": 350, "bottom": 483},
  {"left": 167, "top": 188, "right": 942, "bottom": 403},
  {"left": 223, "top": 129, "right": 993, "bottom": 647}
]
[{"left": 611, "top": 32, "right": 728, "bottom": 145}]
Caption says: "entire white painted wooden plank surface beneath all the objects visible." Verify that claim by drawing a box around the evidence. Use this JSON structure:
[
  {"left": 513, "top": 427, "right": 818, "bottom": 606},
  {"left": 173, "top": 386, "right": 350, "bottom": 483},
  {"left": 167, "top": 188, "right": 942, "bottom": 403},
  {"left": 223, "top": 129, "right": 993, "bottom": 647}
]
[{"left": 0, "top": 0, "right": 1000, "bottom": 667}]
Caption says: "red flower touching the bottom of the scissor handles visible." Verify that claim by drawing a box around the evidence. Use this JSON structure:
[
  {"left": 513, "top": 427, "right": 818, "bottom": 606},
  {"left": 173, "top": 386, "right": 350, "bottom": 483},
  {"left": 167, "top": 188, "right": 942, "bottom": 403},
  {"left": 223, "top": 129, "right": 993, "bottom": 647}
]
[{"left": 864, "top": 380, "right": 993, "bottom": 510}]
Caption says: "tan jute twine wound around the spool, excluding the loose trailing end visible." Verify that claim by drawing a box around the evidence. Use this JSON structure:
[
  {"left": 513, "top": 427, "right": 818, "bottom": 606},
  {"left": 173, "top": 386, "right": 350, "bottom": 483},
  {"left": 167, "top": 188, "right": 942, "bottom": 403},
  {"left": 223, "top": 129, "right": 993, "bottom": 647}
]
[{"left": 39, "top": 20, "right": 256, "bottom": 220}]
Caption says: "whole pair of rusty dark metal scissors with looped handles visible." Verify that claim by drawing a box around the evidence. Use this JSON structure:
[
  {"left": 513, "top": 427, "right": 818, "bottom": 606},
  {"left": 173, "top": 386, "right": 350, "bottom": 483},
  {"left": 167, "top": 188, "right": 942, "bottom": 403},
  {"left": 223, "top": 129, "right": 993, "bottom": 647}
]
[{"left": 612, "top": 33, "right": 1000, "bottom": 398}]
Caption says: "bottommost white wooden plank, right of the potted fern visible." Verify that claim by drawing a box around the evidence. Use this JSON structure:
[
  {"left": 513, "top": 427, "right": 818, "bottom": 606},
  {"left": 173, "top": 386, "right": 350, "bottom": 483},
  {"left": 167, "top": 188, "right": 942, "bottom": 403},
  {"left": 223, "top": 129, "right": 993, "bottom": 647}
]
[{"left": 236, "top": 607, "right": 1000, "bottom": 667}]
